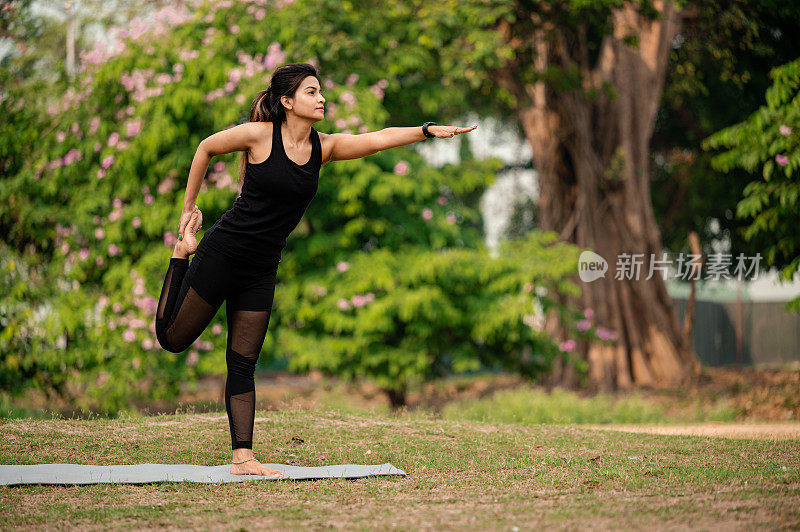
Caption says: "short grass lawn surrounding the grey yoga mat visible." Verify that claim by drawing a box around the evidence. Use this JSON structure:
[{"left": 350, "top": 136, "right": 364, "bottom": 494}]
[{"left": 0, "top": 409, "right": 800, "bottom": 530}]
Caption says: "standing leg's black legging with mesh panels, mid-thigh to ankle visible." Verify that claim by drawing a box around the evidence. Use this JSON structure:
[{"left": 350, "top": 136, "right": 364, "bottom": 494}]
[{"left": 225, "top": 310, "right": 270, "bottom": 449}]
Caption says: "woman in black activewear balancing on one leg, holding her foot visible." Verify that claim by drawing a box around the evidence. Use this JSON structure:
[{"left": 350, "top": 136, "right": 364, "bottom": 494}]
[{"left": 155, "top": 63, "right": 477, "bottom": 478}]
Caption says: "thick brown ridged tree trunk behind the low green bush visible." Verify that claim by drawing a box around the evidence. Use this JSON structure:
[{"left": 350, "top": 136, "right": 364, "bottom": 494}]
[{"left": 498, "top": 1, "right": 699, "bottom": 390}]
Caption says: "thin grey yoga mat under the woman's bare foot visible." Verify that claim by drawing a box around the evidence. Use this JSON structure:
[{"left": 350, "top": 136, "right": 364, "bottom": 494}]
[{"left": 0, "top": 462, "right": 406, "bottom": 486}]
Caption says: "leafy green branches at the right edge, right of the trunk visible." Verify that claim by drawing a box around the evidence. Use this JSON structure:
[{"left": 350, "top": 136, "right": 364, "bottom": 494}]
[{"left": 702, "top": 58, "right": 800, "bottom": 312}]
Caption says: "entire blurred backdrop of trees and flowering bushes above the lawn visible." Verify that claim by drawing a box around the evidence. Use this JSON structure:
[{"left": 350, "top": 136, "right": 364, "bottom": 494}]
[{"left": 0, "top": 0, "right": 800, "bottom": 423}]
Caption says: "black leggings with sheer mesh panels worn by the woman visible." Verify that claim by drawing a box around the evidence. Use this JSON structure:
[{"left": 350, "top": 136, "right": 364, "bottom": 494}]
[{"left": 155, "top": 241, "right": 280, "bottom": 449}]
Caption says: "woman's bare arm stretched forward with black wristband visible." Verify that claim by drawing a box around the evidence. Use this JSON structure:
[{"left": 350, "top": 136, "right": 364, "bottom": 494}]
[{"left": 325, "top": 125, "right": 478, "bottom": 162}]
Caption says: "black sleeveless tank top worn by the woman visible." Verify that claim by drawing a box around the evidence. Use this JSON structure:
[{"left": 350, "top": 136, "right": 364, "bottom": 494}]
[{"left": 202, "top": 122, "right": 322, "bottom": 262}]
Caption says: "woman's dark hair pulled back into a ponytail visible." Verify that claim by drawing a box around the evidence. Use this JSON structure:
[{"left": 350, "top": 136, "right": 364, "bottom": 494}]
[{"left": 239, "top": 63, "right": 322, "bottom": 190}]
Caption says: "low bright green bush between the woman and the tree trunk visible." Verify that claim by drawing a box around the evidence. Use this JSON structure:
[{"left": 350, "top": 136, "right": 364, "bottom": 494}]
[{"left": 275, "top": 232, "right": 593, "bottom": 392}]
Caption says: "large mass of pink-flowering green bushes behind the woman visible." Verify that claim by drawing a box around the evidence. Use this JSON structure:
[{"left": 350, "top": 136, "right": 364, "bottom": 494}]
[{"left": 0, "top": 1, "right": 592, "bottom": 412}]
